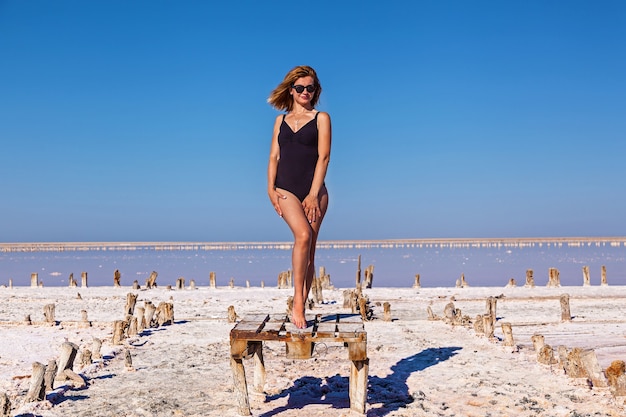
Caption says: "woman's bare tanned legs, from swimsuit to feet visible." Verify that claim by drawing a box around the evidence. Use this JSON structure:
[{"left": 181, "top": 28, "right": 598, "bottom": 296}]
[{"left": 279, "top": 189, "right": 328, "bottom": 328}]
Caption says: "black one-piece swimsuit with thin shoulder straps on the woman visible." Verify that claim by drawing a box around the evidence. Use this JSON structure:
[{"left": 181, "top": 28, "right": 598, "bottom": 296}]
[{"left": 275, "top": 112, "right": 319, "bottom": 201}]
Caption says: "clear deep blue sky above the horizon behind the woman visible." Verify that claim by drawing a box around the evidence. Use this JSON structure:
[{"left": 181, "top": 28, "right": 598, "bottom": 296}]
[{"left": 0, "top": 0, "right": 626, "bottom": 242}]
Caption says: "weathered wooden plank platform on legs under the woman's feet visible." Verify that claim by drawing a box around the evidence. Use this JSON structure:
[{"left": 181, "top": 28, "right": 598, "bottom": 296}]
[{"left": 230, "top": 314, "right": 369, "bottom": 416}]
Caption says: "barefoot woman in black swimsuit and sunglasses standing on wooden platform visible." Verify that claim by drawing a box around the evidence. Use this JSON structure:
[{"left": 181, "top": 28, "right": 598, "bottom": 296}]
[{"left": 267, "top": 66, "right": 331, "bottom": 329}]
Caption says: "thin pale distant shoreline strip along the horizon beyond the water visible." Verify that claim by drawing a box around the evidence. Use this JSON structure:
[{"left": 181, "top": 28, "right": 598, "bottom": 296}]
[{"left": 0, "top": 236, "right": 626, "bottom": 252}]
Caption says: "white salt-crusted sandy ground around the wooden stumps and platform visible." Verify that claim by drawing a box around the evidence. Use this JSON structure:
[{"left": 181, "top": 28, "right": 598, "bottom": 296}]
[{"left": 0, "top": 286, "right": 626, "bottom": 417}]
